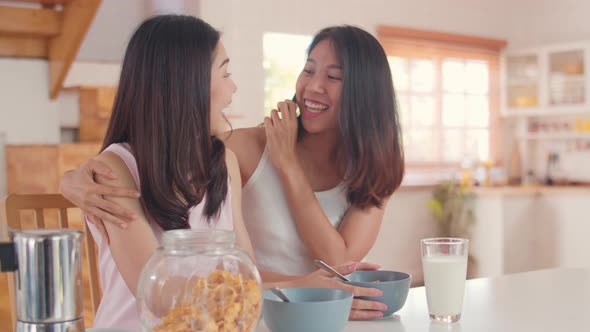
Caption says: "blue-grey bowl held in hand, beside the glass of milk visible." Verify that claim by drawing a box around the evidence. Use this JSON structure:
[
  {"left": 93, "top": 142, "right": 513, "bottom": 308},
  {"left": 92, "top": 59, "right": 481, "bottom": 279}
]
[{"left": 343, "top": 270, "right": 412, "bottom": 317}]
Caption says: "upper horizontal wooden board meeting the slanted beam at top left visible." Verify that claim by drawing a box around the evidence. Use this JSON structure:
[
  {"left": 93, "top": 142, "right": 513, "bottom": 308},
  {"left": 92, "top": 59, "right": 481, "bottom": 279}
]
[{"left": 0, "top": 6, "right": 61, "bottom": 38}]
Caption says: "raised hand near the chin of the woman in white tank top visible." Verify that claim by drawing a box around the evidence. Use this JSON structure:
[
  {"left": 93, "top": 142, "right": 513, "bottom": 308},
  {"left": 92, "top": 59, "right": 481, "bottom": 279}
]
[{"left": 264, "top": 100, "right": 298, "bottom": 171}]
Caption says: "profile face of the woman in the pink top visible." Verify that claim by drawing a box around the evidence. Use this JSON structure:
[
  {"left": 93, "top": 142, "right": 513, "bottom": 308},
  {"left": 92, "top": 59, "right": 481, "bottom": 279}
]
[{"left": 210, "top": 41, "right": 237, "bottom": 135}]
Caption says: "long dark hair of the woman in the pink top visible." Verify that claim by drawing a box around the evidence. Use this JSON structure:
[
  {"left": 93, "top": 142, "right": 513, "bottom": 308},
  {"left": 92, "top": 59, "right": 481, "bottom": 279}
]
[{"left": 102, "top": 15, "right": 228, "bottom": 230}]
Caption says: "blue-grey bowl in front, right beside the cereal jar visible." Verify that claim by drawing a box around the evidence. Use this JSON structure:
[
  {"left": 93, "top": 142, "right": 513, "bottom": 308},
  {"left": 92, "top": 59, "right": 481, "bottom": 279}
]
[{"left": 262, "top": 288, "right": 352, "bottom": 332}]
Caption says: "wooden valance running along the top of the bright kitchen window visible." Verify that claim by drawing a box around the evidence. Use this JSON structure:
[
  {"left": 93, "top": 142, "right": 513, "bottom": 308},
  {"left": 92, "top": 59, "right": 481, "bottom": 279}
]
[{"left": 377, "top": 25, "right": 507, "bottom": 51}]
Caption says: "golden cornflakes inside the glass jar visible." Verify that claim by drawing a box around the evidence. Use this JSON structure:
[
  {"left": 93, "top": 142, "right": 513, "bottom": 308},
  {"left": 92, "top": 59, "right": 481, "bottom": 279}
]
[{"left": 154, "top": 270, "right": 262, "bottom": 332}]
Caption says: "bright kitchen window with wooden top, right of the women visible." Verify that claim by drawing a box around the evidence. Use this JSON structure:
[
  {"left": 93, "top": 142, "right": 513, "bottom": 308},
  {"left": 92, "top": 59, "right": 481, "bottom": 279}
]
[{"left": 378, "top": 26, "right": 505, "bottom": 171}]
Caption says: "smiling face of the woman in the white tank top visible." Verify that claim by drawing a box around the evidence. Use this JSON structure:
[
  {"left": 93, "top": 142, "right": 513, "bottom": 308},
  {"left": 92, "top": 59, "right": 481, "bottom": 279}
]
[{"left": 296, "top": 39, "right": 344, "bottom": 133}]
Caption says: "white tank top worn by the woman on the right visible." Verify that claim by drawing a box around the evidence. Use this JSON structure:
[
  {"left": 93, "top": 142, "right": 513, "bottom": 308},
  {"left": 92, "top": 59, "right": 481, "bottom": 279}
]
[{"left": 242, "top": 147, "right": 349, "bottom": 275}]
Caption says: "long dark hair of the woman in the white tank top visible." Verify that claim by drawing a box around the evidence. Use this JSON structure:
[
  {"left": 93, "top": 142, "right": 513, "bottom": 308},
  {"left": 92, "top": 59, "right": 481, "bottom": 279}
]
[{"left": 299, "top": 25, "right": 404, "bottom": 208}]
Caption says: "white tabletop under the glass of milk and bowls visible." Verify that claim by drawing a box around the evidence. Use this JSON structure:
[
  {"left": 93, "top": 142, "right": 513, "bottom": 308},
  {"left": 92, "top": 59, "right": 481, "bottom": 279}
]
[{"left": 257, "top": 269, "right": 590, "bottom": 332}]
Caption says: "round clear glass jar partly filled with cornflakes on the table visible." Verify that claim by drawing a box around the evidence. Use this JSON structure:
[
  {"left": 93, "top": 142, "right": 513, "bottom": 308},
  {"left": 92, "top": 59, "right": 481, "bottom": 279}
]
[{"left": 136, "top": 230, "right": 262, "bottom": 332}]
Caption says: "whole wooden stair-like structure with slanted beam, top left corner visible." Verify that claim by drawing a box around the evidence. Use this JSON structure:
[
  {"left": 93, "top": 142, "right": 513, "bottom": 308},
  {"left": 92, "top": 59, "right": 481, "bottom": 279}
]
[{"left": 0, "top": 0, "right": 102, "bottom": 99}]
